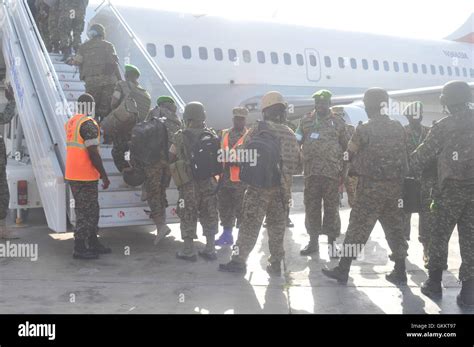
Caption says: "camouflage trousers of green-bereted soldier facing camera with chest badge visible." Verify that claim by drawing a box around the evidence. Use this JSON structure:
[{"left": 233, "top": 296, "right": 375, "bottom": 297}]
[{"left": 304, "top": 176, "right": 341, "bottom": 238}]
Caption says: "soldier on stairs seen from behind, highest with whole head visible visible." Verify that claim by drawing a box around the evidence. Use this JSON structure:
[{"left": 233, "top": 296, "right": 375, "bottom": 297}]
[{"left": 72, "top": 24, "right": 122, "bottom": 122}]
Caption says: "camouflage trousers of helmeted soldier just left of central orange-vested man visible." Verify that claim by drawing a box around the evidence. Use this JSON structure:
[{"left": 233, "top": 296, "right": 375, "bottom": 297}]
[{"left": 177, "top": 178, "right": 219, "bottom": 239}]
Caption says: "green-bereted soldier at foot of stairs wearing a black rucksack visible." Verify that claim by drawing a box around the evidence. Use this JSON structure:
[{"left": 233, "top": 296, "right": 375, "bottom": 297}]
[{"left": 141, "top": 96, "right": 182, "bottom": 245}]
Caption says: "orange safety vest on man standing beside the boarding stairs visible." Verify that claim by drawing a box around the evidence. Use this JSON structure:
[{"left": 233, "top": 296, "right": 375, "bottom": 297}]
[{"left": 65, "top": 114, "right": 100, "bottom": 182}]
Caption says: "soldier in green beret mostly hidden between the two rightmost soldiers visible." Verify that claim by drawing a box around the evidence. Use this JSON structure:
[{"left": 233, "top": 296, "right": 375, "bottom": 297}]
[{"left": 403, "top": 101, "right": 437, "bottom": 266}]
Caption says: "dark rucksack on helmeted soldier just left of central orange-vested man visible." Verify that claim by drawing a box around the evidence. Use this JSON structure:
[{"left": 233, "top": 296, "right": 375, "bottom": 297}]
[{"left": 183, "top": 130, "right": 222, "bottom": 181}]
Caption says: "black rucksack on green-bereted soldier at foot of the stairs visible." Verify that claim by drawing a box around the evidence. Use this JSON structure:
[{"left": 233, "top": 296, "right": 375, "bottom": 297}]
[{"left": 130, "top": 117, "right": 168, "bottom": 165}]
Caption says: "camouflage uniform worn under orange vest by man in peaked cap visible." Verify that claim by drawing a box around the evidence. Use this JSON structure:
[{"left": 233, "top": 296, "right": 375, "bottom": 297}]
[{"left": 218, "top": 128, "right": 246, "bottom": 229}]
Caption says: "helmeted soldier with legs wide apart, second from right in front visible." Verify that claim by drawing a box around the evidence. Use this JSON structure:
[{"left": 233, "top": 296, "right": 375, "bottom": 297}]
[{"left": 323, "top": 88, "right": 408, "bottom": 285}]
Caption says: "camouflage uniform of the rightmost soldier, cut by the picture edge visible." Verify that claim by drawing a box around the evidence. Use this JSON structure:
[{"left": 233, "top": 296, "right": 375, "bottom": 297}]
[{"left": 411, "top": 111, "right": 474, "bottom": 282}]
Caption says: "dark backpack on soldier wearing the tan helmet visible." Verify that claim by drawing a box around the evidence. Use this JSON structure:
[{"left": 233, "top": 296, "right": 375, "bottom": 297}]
[{"left": 240, "top": 121, "right": 282, "bottom": 188}]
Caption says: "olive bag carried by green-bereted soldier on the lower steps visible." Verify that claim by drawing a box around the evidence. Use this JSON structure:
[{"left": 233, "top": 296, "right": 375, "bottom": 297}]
[{"left": 100, "top": 82, "right": 139, "bottom": 137}]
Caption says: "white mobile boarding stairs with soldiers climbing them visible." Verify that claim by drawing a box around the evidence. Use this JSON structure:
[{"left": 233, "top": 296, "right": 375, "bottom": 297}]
[{"left": 0, "top": 0, "right": 183, "bottom": 232}]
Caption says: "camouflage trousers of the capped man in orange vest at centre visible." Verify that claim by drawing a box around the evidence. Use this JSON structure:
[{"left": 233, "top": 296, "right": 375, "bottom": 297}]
[{"left": 217, "top": 182, "right": 246, "bottom": 229}]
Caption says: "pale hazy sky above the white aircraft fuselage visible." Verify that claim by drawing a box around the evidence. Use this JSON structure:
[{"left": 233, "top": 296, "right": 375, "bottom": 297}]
[{"left": 90, "top": 0, "right": 474, "bottom": 39}]
